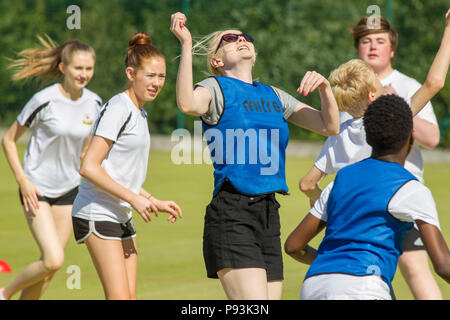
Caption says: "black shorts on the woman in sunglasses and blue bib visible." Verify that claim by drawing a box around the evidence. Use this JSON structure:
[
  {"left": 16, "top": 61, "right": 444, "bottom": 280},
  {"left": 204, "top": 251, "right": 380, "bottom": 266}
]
[{"left": 203, "top": 183, "right": 283, "bottom": 280}]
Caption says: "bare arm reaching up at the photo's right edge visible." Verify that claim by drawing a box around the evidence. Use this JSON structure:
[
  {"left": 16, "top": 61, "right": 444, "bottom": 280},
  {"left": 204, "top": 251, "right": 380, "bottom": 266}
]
[{"left": 411, "top": 9, "right": 450, "bottom": 116}]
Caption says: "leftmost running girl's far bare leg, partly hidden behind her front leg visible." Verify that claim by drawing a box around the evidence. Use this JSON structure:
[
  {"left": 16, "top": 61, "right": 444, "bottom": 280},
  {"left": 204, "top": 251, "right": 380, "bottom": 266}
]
[{"left": 20, "top": 205, "right": 73, "bottom": 300}]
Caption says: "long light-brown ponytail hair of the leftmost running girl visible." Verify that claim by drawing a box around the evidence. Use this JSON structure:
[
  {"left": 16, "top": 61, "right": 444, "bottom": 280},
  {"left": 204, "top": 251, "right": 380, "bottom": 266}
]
[{"left": 8, "top": 35, "right": 95, "bottom": 81}]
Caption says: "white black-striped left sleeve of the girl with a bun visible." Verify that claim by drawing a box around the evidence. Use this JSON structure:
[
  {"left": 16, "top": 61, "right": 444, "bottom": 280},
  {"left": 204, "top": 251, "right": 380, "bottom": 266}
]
[{"left": 93, "top": 103, "right": 131, "bottom": 142}]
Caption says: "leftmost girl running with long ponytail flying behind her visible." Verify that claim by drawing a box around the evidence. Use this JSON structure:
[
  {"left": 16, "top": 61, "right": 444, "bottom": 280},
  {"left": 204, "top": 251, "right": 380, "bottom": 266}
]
[{"left": 0, "top": 36, "right": 102, "bottom": 299}]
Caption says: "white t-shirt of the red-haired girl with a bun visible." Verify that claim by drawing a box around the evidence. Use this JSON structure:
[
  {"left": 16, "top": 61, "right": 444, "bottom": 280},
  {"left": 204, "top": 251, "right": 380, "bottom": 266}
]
[{"left": 72, "top": 92, "right": 150, "bottom": 223}]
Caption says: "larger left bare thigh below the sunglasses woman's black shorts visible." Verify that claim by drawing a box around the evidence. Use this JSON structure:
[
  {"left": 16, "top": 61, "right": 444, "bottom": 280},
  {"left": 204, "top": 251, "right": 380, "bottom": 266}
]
[{"left": 217, "top": 268, "right": 269, "bottom": 300}]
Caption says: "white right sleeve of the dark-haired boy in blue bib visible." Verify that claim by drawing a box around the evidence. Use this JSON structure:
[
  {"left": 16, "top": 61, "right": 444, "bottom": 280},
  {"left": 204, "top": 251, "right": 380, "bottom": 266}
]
[{"left": 388, "top": 180, "right": 440, "bottom": 229}]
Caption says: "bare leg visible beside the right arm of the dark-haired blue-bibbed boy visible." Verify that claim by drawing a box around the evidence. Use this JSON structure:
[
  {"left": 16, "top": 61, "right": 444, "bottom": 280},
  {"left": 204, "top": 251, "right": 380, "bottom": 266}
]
[{"left": 398, "top": 250, "right": 443, "bottom": 300}]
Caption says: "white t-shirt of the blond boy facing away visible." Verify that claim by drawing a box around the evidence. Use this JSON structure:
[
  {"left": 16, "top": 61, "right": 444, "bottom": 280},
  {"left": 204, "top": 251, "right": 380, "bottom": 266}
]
[{"left": 314, "top": 118, "right": 372, "bottom": 174}]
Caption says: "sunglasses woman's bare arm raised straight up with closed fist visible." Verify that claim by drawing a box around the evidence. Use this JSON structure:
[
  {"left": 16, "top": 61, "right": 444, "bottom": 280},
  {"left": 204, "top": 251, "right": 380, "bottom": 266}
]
[{"left": 170, "top": 12, "right": 212, "bottom": 116}]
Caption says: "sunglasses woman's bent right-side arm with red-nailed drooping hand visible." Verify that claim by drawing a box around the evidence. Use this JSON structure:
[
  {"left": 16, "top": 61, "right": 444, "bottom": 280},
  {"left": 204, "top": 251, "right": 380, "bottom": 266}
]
[{"left": 288, "top": 71, "right": 339, "bottom": 136}]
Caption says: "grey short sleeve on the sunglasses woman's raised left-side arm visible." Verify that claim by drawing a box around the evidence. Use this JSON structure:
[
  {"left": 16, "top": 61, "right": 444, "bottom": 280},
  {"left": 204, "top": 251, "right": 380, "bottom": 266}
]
[{"left": 194, "top": 77, "right": 224, "bottom": 126}]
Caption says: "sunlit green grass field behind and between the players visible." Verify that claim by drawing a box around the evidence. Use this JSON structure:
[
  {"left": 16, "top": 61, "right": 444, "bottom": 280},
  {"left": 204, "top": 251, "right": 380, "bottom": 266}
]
[{"left": 0, "top": 146, "right": 450, "bottom": 300}]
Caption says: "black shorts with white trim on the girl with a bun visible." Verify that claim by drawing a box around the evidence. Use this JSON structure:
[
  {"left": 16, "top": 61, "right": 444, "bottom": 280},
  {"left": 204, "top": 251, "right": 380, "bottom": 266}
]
[{"left": 72, "top": 217, "right": 136, "bottom": 243}]
